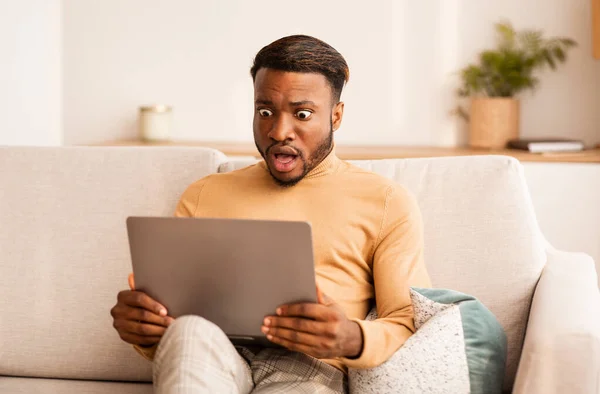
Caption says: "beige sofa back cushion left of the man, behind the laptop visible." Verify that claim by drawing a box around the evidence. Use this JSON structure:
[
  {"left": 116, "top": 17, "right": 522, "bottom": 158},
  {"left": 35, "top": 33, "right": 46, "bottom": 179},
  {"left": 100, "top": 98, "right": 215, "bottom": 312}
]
[{"left": 0, "top": 147, "right": 225, "bottom": 381}]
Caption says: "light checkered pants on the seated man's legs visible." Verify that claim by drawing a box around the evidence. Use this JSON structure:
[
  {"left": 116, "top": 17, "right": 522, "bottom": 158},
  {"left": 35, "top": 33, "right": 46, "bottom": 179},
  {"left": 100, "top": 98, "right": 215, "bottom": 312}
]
[{"left": 153, "top": 316, "right": 348, "bottom": 394}]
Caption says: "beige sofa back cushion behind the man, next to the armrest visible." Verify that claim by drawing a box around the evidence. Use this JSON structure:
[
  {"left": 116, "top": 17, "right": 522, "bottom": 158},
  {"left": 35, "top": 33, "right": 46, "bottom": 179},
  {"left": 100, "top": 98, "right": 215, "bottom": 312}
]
[{"left": 219, "top": 156, "right": 546, "bottom": 389}]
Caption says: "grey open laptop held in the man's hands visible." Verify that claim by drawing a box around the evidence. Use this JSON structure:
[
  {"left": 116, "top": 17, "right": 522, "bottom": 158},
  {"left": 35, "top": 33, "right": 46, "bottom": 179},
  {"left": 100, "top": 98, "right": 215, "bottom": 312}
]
[{"left": 127, "top": 217, "right": 317, "bottom": 347}]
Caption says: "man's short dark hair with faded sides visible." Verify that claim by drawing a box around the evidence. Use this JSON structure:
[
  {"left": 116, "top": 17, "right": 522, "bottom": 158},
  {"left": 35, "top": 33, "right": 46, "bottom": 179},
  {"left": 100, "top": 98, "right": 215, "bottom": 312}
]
[{"left": 250, "top": 35, "right": 350, "bottom": 104}]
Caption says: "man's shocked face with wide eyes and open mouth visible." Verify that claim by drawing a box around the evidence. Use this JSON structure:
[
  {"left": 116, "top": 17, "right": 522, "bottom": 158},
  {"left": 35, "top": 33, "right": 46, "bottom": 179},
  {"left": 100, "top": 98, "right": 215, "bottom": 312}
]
[{"left": 253, "top": 68, "right": 344, "bottom": 187}]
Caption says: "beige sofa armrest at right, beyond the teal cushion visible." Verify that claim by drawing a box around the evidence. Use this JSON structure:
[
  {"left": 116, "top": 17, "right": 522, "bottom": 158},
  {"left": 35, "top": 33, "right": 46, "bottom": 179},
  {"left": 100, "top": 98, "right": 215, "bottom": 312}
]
[{"left": 513, "top": 250, "right": 600, "bottom": 394}]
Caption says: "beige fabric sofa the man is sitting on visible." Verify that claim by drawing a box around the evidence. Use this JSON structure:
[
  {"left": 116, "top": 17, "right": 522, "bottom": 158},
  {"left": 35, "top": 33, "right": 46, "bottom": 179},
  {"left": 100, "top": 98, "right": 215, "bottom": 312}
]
[{"left": 0, "top": 147, "right": 600, "bottom": 394}]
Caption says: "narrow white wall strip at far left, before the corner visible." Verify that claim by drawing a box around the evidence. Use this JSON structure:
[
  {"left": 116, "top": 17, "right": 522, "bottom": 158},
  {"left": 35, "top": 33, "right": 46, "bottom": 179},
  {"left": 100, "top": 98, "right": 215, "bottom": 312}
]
[{"left": 0, "top": 0, "right": 62, "bottom": 145}]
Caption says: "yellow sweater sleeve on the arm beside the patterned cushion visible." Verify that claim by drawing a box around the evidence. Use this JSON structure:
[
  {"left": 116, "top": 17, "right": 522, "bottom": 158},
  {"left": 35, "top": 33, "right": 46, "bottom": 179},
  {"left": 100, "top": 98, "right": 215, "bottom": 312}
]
[{"left": 341, "top": 186, "right": 431, "bottom": 368}]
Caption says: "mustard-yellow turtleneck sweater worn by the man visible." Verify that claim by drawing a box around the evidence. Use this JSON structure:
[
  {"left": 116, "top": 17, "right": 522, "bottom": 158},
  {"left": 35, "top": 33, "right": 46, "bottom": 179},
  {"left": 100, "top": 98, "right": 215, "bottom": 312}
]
[{"left": 138, "top": 152, "right": 430, "bottom": 371}]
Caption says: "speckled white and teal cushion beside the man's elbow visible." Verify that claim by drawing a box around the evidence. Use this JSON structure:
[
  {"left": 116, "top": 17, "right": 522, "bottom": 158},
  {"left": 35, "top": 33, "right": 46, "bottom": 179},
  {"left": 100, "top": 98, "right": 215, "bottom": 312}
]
[{"left": 349, "top": 288, "right": 506, "bottom": 394}]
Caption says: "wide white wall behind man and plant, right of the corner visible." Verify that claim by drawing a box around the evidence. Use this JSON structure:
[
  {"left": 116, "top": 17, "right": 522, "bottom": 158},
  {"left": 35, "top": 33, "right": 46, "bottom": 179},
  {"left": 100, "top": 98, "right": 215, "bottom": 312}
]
[{"left": 64, "top": 0, "right": 600, "bottom": 145}]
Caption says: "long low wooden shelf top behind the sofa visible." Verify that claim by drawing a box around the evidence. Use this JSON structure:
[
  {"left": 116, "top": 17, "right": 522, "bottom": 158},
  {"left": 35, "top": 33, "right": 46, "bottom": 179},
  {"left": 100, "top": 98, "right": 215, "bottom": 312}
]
[{"left": 86, "top": 141, "right": 600, "bottom": 163}]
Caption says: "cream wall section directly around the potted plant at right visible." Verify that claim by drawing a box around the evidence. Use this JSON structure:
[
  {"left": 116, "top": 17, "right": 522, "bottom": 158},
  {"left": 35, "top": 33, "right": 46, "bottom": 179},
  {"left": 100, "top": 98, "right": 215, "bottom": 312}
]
[{"left": 458, "top": 0, "right": 600, "bottom": 148}]
